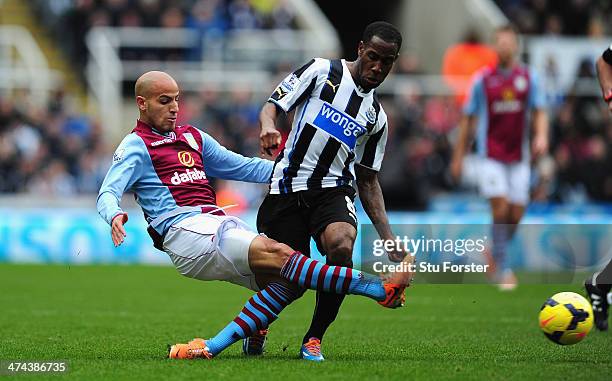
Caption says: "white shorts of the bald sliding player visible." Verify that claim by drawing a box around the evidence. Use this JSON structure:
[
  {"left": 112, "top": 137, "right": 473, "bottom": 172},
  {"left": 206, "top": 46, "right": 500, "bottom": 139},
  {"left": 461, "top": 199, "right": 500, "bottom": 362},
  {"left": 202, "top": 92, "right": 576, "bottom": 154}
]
[{"left": 164, "top": 213, "right": 259, "bottom": 291}]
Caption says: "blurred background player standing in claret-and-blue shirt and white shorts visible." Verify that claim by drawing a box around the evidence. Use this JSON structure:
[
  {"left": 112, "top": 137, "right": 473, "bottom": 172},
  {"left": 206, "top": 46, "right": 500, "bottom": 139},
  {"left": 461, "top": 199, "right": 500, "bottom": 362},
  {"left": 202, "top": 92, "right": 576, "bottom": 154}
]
[{"left": 450, "top": 25, "right": 548, "bottom": 289}]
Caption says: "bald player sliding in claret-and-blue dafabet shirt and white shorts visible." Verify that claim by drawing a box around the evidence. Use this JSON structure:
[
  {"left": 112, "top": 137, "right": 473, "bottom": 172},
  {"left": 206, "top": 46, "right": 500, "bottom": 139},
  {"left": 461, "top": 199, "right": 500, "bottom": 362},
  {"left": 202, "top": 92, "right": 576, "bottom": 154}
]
[{"left": 97, "top": 71, "right": 412, "bottom": 359}]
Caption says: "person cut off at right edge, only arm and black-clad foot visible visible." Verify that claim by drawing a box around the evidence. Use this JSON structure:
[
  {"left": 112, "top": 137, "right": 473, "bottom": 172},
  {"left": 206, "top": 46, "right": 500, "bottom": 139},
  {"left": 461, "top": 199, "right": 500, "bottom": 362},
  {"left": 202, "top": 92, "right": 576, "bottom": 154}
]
[{"left": 584, "top": 45, "right": 612, "bottom": 331}]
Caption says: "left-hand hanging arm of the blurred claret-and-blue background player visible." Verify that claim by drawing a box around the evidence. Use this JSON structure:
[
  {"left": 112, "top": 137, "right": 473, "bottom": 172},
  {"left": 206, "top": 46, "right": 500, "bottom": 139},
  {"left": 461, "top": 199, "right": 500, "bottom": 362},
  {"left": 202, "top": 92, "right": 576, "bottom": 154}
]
[{"left": 450, "top": 76, "right": 484, "bottom": 182}]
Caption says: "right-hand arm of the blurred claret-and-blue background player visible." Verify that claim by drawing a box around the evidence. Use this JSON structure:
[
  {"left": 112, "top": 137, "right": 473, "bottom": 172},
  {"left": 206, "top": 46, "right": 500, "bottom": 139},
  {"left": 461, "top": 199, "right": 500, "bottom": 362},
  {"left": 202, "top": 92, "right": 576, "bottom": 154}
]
[{"left": 529, "top": 72, "right": 548, "bottom": 158}]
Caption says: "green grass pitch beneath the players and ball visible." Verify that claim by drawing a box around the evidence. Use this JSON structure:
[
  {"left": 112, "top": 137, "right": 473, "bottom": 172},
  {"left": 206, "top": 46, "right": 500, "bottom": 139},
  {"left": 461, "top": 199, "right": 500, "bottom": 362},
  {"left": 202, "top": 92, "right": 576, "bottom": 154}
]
[{"left": 0, "top": 265, "right": 612, "bottom": 381}]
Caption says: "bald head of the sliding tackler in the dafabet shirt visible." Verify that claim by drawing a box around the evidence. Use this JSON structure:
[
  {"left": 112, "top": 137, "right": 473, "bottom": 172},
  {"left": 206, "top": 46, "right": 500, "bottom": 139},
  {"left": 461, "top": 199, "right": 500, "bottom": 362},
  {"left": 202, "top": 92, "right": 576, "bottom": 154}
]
[{"left": 134, "top": 71, "right": 179, "bottom": 132}]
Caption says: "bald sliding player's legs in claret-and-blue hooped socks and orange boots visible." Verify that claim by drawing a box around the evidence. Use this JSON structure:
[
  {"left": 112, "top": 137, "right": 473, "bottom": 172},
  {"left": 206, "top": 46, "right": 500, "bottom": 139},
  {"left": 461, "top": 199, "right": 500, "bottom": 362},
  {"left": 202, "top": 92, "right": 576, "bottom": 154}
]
[{"left": 168, "top": 236, "right": 411, "bottom": 359}]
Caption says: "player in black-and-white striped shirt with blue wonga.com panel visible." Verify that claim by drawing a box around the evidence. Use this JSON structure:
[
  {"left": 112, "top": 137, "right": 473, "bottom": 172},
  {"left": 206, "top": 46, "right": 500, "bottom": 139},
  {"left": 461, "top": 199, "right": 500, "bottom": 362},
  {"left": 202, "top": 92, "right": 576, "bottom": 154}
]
[{"left": 252, "top": 22, "right": 403, "bottom": 361}]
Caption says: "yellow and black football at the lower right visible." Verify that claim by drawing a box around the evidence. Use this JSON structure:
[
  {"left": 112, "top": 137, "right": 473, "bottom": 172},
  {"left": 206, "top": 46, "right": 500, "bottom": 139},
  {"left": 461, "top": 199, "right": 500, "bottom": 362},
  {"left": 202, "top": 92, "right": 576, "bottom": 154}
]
[{"left": 539, "top": 292, "right": 593, "bottom": 345}]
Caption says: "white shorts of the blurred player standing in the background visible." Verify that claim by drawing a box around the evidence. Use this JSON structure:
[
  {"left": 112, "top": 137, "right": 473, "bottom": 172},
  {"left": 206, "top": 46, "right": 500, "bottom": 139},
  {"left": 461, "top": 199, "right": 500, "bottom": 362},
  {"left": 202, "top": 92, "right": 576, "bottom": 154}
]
[{"left": 478, "top": 157, "right": 530, "bottom": 205}]
